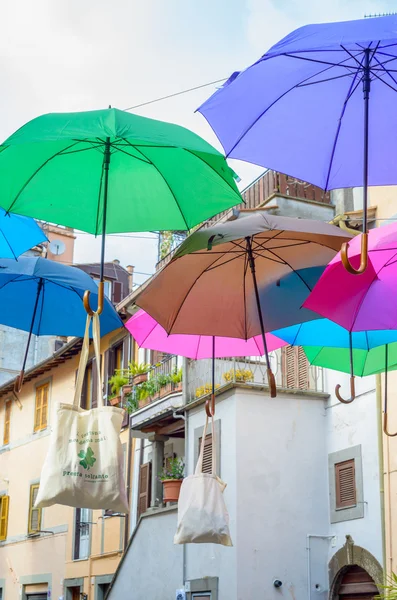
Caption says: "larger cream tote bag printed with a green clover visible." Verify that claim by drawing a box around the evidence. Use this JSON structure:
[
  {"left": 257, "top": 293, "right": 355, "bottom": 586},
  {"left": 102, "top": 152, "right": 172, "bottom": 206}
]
[{"left": 35, "top": 313, "right": 128, "bottom": 513}]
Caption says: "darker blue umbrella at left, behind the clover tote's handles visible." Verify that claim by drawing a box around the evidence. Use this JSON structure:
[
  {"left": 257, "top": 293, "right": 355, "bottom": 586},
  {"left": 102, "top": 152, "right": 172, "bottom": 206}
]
[{"left": 0, "top": 257, "right": 123, "bottom": 390}]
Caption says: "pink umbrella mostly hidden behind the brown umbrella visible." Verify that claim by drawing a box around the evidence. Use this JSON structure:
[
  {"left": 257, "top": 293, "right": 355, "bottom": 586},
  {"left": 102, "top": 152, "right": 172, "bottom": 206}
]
[{"left": 125, "top": 310, "right": 288, "bottom": 416}]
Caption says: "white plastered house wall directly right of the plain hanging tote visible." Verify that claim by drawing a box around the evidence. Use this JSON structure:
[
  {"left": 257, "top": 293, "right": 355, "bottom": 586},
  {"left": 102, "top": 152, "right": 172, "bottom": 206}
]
[{"left": 236, "top": 390, "right": 328, "bottom": 600}]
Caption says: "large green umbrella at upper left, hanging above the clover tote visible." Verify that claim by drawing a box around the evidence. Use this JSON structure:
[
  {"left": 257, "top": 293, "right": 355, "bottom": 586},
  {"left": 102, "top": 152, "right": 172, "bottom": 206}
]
[{"left": 0, "top": 107, "right": 241, "bottom": 308}]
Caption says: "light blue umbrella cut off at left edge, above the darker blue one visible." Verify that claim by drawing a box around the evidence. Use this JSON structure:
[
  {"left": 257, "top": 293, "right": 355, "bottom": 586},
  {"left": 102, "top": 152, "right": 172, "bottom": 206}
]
[{"left": 0, "top": 208, "right": 47, "bottom": 258}]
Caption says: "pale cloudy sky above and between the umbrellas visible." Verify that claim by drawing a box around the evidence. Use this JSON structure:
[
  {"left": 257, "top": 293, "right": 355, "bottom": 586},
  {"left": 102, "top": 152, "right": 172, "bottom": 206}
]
[{"left": 0, "top": 0, "right": 395, "bottom": 283}]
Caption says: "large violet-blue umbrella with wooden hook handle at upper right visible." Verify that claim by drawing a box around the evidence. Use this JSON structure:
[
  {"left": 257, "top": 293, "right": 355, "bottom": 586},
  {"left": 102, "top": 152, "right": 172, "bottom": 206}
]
[{"left": 198, "top": 15, "right": 397, "bottom": 273}]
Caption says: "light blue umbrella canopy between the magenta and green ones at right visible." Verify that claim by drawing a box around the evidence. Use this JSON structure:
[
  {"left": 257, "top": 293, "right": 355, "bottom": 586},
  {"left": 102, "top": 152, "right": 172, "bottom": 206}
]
[{"left": 273, "top": 319, "right": 397, "bottom": 351}]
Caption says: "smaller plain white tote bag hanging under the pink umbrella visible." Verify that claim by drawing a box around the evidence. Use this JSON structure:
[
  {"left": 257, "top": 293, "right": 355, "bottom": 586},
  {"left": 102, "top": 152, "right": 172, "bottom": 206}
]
[{"left": 174, "top": 416, "right": 233, "bottom": 546}]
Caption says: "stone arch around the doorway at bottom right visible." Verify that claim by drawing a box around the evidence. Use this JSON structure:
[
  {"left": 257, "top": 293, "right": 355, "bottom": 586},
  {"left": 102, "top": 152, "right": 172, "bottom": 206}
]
[{"left": 328, "top": 535, "right": 383, "bottom": 600}]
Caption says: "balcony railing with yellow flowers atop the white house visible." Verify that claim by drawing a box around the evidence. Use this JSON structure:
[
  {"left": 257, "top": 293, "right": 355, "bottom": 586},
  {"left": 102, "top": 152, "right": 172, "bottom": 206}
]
[{"left": 187, "top": 350, "right": 324, "bottom": 402}]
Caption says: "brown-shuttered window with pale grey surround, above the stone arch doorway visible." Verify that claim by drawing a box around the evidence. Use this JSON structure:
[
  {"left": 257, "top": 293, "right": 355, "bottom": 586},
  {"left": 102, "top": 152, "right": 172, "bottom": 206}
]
[{"left": 328, "top": 446, "right": 365, "bottom": 523}]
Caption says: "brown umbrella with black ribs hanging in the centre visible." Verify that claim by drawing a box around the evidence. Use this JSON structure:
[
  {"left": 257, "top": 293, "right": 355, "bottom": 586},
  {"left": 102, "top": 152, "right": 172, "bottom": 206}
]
[{"left": 136, "top": 211, "right": 351, "bottom": 396}]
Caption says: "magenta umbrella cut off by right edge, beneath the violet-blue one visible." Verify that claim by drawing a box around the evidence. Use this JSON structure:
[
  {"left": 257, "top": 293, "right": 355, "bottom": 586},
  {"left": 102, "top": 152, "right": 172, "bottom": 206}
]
[{"left": 303, "top": 223, "right": 397, "bottom": 402}]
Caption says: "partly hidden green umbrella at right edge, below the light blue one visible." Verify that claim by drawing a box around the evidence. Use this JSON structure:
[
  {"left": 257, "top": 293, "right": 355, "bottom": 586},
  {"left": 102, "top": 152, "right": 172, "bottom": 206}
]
[{"left": 303, "top": 342, "right": 397, "bottom": 437}]
